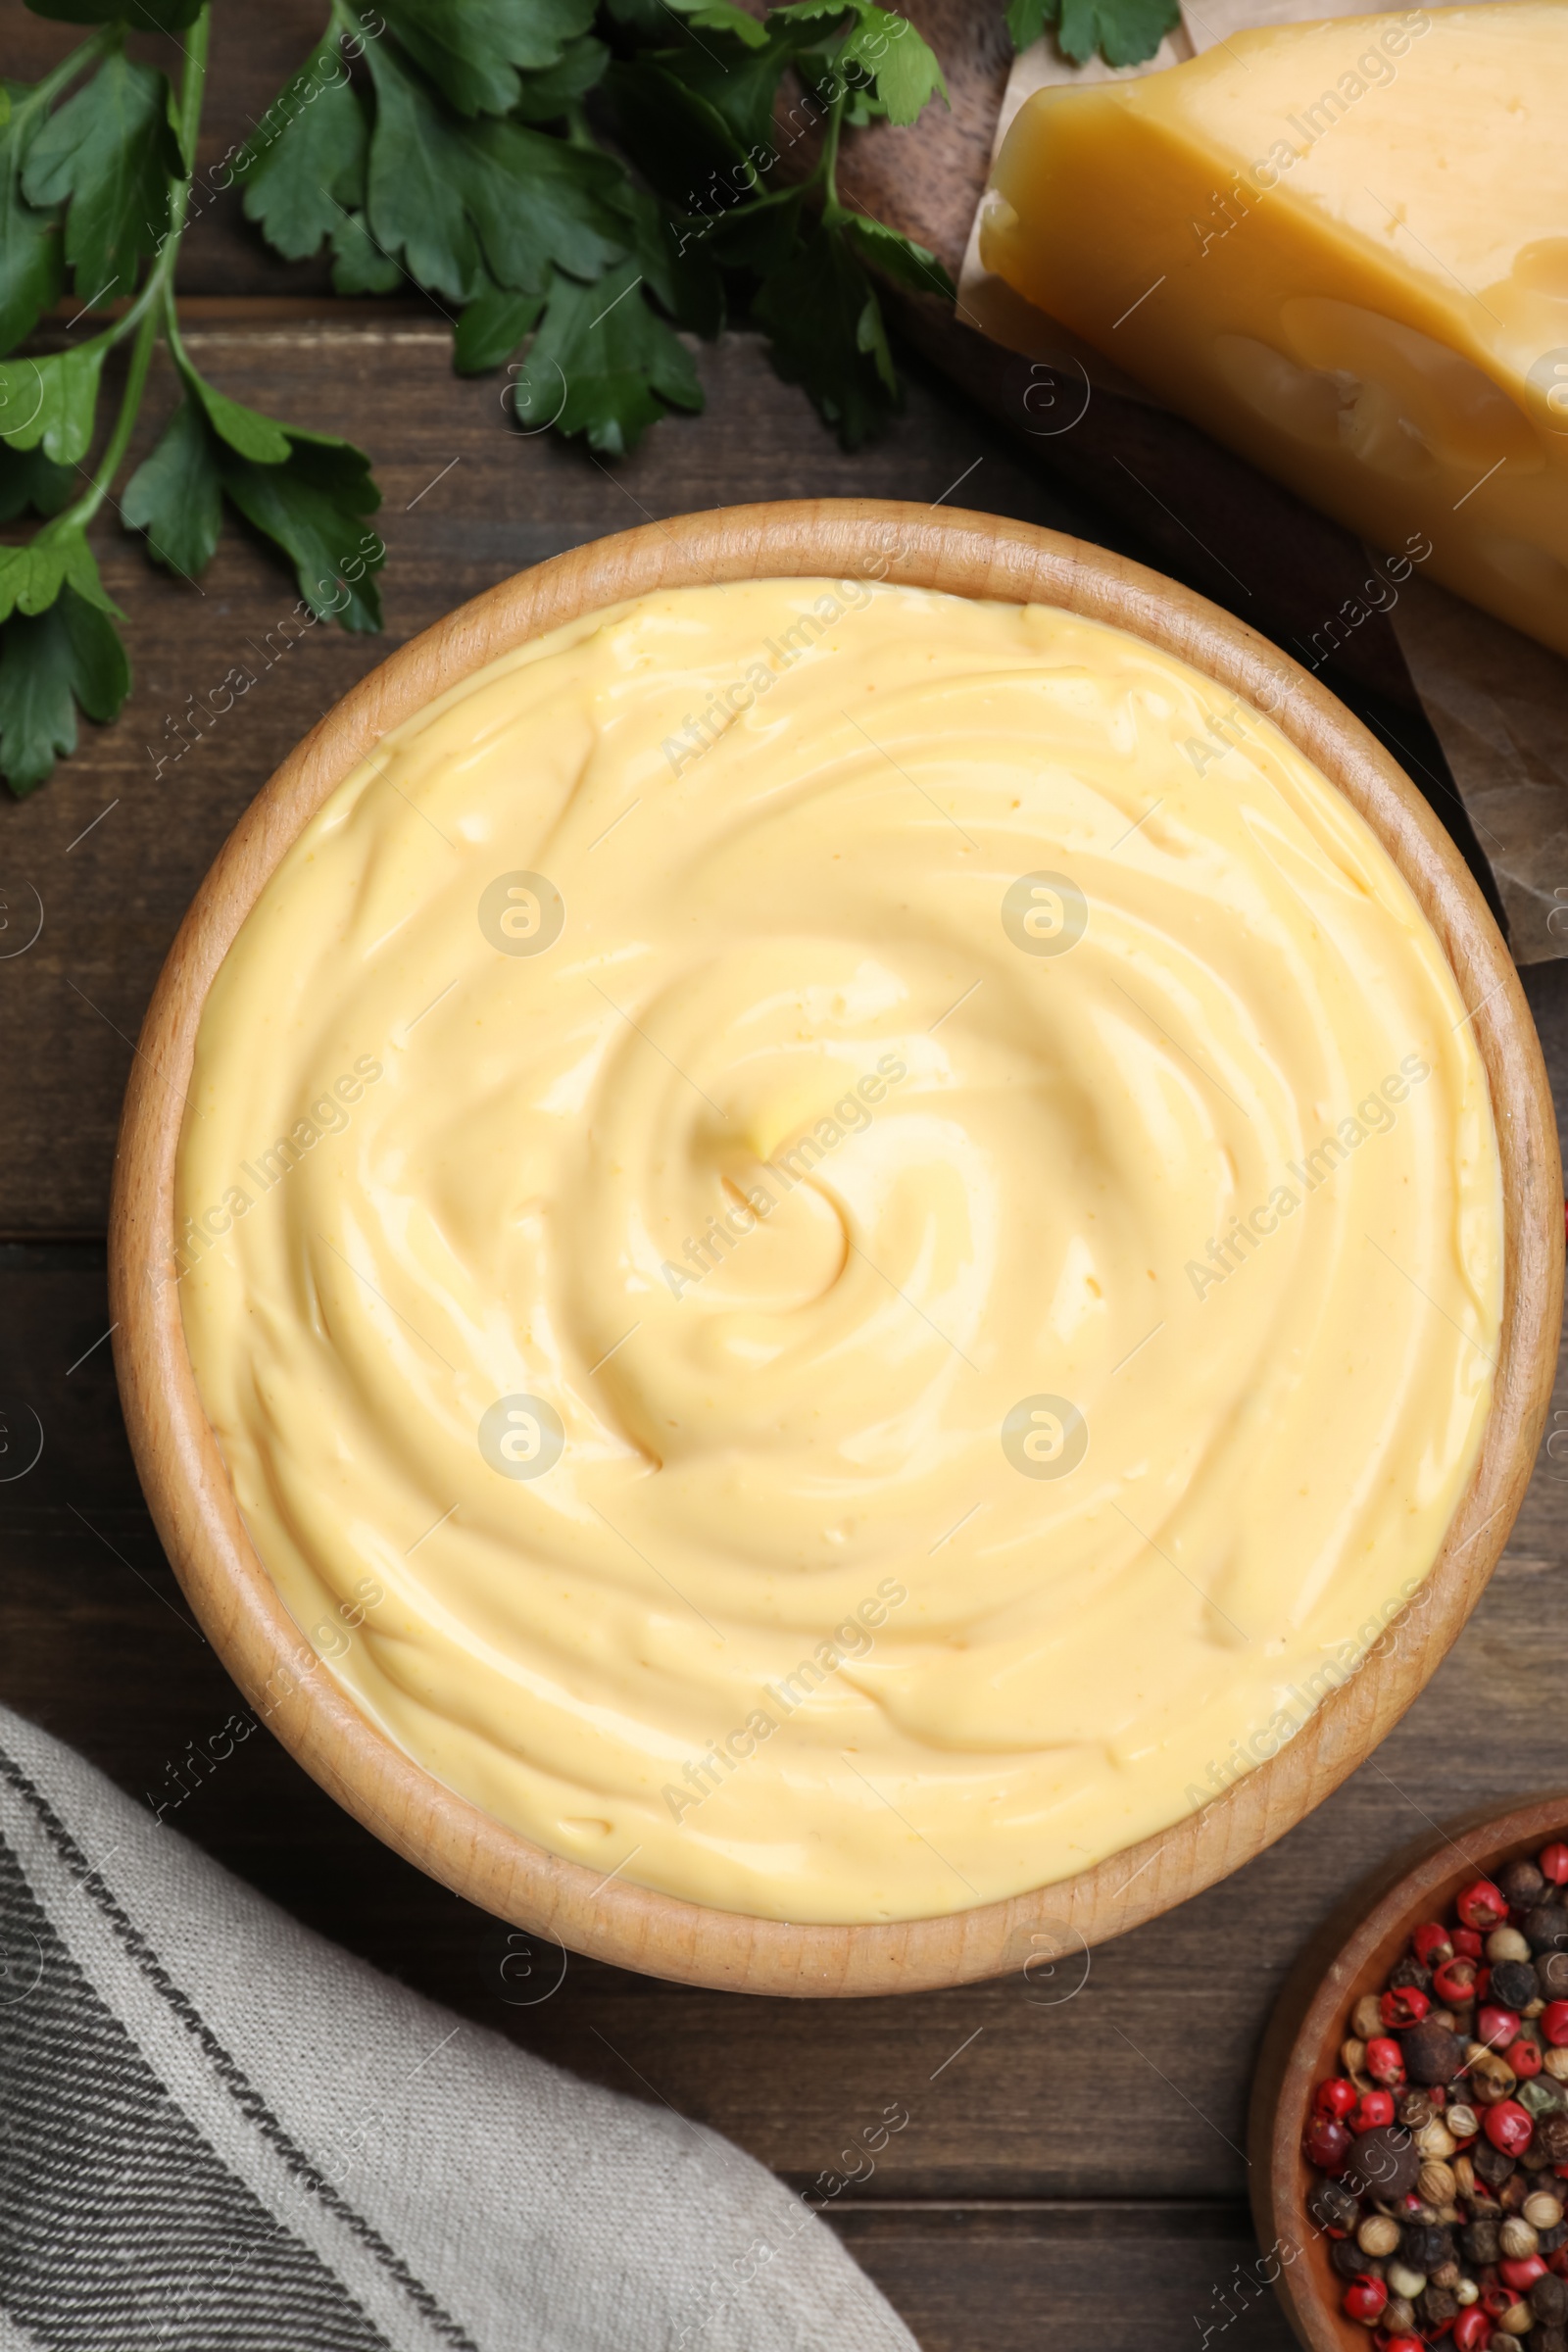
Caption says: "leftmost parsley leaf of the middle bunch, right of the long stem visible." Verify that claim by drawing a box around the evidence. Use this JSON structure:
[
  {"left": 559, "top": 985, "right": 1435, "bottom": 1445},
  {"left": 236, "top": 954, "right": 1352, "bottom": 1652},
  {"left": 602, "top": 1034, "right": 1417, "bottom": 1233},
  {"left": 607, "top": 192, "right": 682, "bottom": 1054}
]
[{"left": 235, "top": 33, "right": 369, "bottom": 261}]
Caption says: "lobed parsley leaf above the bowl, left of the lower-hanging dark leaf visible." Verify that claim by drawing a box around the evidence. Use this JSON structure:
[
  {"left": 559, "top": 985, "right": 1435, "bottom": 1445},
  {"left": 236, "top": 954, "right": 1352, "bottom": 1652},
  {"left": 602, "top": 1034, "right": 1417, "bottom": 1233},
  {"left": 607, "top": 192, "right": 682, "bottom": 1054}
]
[{"left": 526, "top": 261, "right": 703, "bottom": 457}]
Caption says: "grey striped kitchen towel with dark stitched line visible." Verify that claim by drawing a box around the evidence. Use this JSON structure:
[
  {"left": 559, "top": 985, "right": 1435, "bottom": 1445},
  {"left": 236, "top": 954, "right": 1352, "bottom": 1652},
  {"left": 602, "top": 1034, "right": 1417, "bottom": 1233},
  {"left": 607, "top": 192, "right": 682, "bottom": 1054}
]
[{"left": 0, "top": 1710, "right": 914, "bottom": 2352}]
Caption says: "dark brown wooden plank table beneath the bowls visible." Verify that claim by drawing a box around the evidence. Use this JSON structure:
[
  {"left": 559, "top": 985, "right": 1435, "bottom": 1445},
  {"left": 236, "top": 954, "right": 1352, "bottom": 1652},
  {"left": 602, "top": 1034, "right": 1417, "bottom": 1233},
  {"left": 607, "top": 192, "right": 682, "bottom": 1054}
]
[{"left": 0, "top": 0, "right": 1568, "bottom": 2352}]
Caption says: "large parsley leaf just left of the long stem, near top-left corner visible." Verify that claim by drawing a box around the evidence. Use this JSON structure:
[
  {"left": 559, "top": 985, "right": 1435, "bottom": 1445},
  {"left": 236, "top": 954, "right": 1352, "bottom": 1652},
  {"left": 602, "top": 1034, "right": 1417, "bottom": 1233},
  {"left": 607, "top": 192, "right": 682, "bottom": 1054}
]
[{"left": 22, "top": 49, "right": 186, "bottom": 301}]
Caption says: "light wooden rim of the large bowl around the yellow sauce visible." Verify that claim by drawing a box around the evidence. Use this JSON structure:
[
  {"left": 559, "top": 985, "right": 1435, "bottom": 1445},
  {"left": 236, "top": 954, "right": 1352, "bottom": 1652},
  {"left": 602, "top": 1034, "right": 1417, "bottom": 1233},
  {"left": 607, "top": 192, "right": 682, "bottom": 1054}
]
[{"left": 111, "top": 499, "right": 1563, "bottom": 1994}]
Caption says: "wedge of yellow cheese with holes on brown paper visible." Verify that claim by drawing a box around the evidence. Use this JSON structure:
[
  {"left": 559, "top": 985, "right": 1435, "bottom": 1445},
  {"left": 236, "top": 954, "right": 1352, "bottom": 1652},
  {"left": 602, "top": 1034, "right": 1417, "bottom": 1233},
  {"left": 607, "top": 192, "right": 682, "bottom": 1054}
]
[{"left": 980, "top": 0, "right": 1568, "bottom": 654}]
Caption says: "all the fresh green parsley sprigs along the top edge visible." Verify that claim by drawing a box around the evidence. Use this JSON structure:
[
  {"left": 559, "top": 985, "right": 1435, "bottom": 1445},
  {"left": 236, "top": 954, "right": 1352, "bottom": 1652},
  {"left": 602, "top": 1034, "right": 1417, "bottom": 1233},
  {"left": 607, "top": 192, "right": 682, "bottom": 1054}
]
[{"left": 0, "top": 0, "right": 1152, "bottom": 793}]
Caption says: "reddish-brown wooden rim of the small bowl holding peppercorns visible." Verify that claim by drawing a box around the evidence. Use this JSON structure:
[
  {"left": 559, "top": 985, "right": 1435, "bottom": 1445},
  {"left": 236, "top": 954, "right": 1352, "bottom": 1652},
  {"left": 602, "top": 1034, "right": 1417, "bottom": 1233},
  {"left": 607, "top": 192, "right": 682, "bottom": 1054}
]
[{"left": 1249, "top": 1789, "right": 1568, "bottom": 2352}]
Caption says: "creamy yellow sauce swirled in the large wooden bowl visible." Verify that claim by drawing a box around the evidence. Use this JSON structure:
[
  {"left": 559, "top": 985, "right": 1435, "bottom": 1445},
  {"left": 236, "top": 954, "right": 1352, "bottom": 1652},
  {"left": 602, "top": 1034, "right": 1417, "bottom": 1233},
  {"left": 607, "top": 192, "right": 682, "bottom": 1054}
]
[{"left": 176, "top": 581, "right": 1502, "bottom": 1919}]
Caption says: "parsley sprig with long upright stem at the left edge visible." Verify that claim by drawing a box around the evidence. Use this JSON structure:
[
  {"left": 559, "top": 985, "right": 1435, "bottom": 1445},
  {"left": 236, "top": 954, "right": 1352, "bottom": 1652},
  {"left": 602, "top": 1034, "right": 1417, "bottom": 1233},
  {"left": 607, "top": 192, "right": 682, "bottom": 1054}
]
[{"left": 0, "top": 0, "right": 385, "bottom": 795}]
